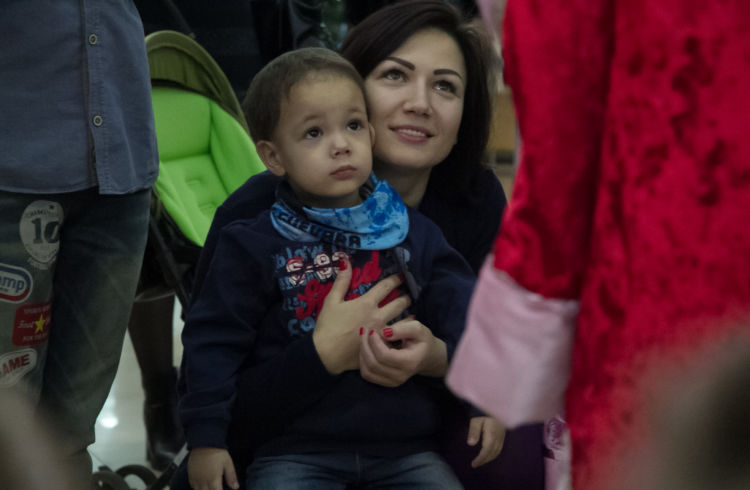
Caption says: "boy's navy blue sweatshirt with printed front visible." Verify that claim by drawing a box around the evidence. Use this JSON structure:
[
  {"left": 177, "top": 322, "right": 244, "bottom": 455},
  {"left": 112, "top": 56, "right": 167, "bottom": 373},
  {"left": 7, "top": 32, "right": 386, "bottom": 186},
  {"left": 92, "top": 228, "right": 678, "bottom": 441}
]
[{"left": 180, "top": 197, "right": 474, "bottom": 456}]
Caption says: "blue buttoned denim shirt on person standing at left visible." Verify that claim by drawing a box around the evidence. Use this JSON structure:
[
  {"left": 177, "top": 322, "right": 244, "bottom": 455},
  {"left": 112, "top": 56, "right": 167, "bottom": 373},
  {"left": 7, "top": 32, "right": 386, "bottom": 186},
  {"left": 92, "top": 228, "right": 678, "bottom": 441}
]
[{"left": 0, "top": 0, "right": 158, "bottom": 194}]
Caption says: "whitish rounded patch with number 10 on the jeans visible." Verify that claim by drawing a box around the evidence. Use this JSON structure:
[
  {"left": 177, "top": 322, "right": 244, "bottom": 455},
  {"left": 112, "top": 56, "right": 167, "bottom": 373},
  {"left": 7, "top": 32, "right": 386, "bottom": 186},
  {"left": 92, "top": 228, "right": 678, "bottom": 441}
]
[{"left": 19, "top": 201, "right": 63, "bottom": 269}]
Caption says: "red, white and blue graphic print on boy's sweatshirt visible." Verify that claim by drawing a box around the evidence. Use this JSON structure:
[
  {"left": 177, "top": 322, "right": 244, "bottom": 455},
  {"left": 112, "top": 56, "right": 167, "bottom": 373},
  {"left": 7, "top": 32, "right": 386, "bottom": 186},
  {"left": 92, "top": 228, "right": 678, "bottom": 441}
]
[{"left": 273, "top": 243, "right": 410, "bottom": 337}]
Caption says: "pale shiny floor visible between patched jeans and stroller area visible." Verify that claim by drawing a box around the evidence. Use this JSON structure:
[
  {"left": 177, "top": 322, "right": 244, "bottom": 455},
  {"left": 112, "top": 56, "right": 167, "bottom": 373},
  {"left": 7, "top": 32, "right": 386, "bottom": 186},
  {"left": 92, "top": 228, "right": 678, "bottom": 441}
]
[{"left": 89, "top": 303, "right": 182, "bottom": 478}]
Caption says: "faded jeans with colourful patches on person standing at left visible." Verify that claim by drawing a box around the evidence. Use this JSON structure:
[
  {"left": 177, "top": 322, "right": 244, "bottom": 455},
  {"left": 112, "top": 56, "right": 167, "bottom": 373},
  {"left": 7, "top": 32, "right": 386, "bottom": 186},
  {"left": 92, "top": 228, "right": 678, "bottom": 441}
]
[{"left": 0, "top": 189, "right": 150, "bottom": 482}]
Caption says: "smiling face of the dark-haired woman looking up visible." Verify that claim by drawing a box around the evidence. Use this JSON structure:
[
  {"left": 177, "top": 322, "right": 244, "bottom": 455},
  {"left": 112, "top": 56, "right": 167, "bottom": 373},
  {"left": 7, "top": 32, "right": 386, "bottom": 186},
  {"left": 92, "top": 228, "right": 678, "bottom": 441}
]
[{"left": 365, "top": 29, "right": 466, "bottom": 170}]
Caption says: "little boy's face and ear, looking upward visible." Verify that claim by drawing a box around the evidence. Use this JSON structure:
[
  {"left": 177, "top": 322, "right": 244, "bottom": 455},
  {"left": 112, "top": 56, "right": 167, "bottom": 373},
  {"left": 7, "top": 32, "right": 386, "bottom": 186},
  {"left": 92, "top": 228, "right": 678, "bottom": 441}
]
[{"left": 257, "top": 74, "right": 374, "bottom": 208}]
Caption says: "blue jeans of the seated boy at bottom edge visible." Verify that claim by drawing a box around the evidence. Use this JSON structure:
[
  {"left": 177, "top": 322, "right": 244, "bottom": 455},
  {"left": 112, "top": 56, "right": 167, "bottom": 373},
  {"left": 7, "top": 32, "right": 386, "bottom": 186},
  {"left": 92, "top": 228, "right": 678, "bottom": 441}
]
[{"left": 247, "top": 452, "right": 463, "bottom": 490}]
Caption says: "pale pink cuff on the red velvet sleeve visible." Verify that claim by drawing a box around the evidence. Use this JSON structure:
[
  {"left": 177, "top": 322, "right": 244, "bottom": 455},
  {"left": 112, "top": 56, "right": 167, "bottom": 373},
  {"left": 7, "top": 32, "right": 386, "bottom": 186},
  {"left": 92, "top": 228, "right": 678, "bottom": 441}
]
[{"left": 446, "top": 256, "right": 578, "bottom": 427}]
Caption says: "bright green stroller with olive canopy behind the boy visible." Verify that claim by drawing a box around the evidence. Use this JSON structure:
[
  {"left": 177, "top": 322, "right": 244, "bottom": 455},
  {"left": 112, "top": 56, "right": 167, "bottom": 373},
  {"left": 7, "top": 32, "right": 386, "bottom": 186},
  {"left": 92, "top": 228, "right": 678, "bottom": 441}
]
[{"left": 142, "top": 27, "right": 264, "bottom": 306}]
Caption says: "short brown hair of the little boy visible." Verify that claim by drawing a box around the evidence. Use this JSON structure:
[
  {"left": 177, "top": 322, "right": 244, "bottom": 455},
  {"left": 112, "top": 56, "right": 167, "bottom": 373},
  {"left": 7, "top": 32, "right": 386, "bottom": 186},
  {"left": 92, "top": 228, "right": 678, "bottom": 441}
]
[{"left": 242, "top": 48, "right": 366, "bottom": 143}]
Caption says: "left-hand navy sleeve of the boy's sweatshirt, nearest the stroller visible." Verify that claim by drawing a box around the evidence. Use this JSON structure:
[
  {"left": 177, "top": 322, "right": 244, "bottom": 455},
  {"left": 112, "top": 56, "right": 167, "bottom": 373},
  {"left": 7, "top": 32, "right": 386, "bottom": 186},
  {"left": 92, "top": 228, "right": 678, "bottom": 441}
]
[{"left": 179, "top": 225, "right": 270, "bottom": 447}]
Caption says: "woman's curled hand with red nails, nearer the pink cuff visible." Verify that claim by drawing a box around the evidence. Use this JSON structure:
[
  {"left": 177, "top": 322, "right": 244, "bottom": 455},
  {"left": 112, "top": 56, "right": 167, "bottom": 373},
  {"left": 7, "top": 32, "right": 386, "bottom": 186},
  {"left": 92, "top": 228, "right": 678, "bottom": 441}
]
[{"left": 359, "top": 316, "right": 448, "bottom": 387}]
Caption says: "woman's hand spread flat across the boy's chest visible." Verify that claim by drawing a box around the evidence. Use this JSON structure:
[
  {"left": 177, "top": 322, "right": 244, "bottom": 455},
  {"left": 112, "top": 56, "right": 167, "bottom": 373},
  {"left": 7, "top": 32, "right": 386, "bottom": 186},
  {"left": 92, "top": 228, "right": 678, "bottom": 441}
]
[{"left": 312, "top": 259, "right": 411, "bottom": 374}]
